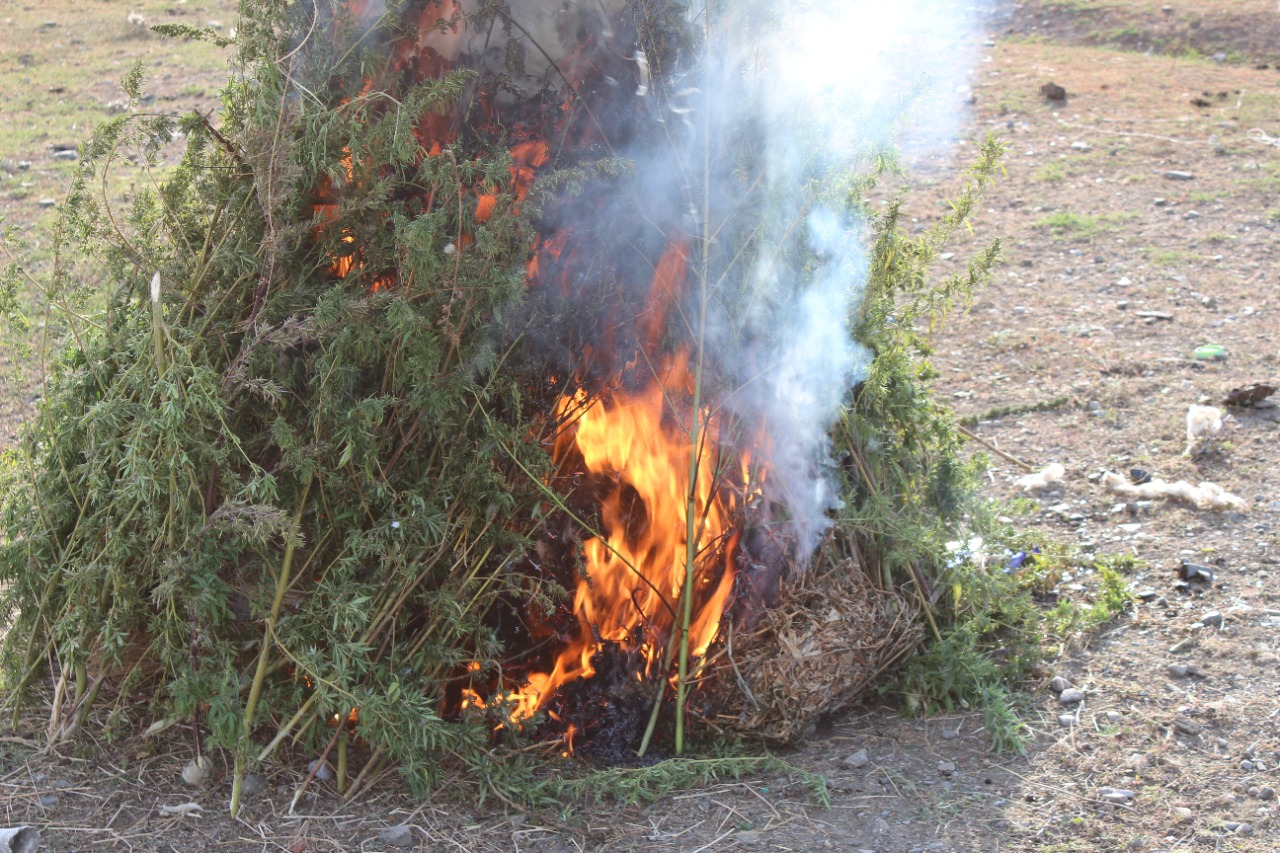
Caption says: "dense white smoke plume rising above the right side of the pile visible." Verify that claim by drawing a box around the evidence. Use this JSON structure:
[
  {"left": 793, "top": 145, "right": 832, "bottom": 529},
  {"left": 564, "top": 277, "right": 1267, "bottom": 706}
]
[{"left": 686, "top": 0, "right": 982, "bottom": 558}]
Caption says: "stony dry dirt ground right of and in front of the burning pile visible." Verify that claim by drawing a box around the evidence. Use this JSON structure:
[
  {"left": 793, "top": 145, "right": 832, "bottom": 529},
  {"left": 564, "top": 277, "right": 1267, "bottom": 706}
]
[{"left": 0, "top": 0, "right": 1280, "bottom": 853}]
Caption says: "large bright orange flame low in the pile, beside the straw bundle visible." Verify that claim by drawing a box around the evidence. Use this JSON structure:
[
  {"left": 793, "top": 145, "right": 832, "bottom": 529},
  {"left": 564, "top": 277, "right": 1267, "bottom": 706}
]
[{"left": 509, "top": 249, "right": 733, "bottom": 721}]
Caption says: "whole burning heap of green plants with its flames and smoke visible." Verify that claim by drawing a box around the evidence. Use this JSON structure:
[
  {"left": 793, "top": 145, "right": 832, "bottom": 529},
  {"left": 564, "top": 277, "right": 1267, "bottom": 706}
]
[{"left": 0, "top": 0, "right": 996, "bottom": 808}]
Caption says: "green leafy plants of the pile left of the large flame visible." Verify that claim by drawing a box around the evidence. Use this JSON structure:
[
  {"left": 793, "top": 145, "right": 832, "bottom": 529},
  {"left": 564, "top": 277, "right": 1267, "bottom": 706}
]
[{"left": 0, "top": 1, "right": 547, "bottom": 790}]
